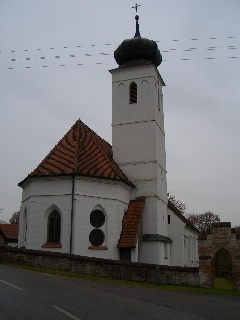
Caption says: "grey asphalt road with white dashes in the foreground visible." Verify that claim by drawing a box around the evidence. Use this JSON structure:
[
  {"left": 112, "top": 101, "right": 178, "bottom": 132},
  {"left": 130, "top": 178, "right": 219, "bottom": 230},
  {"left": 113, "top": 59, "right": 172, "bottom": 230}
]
[{"left": 0, "top": 265, "right": 240, "bottom": 320}]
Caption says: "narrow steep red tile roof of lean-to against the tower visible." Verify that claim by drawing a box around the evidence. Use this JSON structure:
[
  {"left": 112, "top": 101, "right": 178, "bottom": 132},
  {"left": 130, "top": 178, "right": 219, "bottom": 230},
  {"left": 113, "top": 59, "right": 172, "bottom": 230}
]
[{"left": 118, "top": 199, "right": 145, "bottom": 248}]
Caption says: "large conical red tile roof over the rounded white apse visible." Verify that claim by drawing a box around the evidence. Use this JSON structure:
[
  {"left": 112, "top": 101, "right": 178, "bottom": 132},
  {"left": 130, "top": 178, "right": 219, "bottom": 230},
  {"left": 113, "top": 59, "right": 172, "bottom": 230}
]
[{"left": 19, "top": 120, "right": 135, "bottom": 187}]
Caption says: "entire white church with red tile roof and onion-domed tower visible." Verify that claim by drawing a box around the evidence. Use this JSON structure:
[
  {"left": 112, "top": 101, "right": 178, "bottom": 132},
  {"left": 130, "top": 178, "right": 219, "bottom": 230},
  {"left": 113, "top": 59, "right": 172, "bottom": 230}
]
[{"left": 18, "top": 15, "right": 199, "bottom": 267}]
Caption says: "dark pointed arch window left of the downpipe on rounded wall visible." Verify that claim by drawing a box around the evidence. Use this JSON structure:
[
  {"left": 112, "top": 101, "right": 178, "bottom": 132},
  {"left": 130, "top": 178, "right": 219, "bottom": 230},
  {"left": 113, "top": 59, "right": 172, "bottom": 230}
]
[{"left": 47, "top": 210, "right": 61, "bottom": 243}]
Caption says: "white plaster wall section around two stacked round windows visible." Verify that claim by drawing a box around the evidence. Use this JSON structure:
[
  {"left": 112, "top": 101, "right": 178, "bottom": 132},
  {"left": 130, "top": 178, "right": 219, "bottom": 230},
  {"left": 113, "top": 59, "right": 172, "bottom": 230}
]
[{"left": 73, "top": 180, "right": 130, "bottom": 260}]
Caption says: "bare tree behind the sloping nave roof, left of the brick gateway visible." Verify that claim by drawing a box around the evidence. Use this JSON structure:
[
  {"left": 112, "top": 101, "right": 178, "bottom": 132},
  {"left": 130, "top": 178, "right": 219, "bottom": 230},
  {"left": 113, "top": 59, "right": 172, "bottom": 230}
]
[{"left": 186, "top": 211, "right": 220, "bottom": 232}]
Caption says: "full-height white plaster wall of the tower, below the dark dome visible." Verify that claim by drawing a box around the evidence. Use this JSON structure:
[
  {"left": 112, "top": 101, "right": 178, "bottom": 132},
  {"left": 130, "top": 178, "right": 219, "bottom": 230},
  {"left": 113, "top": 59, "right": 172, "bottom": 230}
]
[{"left": 110, "top": 65, "right": 170, "bottom": 264}]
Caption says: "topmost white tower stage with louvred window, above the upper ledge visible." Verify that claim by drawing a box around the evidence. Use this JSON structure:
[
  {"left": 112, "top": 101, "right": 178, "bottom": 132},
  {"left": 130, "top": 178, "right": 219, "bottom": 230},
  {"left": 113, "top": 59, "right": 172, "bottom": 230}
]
[{"left": 110, "top": 65, "right": 164, "bottom": 125}]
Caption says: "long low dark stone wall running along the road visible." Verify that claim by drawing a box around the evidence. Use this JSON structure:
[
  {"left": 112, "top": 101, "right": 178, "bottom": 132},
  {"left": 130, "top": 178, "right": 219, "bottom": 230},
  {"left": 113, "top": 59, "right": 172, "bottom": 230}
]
[{"left": 0, "top": 246, "right": 199, "bottom": 286}]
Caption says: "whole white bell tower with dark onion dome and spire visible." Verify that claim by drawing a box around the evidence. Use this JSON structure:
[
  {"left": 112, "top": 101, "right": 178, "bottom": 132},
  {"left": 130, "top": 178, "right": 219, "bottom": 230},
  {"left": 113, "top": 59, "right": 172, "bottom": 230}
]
[{"left": 110, "top": 15, "right": 171, "bottom": 264}]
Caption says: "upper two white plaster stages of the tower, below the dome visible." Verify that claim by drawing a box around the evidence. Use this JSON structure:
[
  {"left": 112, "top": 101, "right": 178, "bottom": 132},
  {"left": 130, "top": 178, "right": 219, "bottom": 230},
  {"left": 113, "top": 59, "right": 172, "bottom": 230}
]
[{"left": 111, "top": 65, "right": 165, "bottom": 169}]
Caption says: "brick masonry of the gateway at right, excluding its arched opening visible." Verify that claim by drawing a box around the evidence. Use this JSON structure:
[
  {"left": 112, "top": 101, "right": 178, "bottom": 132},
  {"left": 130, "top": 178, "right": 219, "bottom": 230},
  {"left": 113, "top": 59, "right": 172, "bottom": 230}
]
[{"left": 198, "top": 222, "right": 240, "bottom": 290}]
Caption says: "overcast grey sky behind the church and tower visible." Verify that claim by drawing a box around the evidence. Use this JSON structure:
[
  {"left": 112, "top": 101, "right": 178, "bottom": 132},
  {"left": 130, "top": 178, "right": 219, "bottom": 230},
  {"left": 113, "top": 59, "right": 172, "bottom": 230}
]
[{"left": 0, "top": 0, "right": 240, "bottom": 226}]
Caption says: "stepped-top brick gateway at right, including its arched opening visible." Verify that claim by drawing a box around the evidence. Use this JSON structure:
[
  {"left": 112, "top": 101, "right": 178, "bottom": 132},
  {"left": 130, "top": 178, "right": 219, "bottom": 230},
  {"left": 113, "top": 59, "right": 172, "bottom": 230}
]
[{"left": 198, "top": 222, "right": 240, "bottom": 290}]
